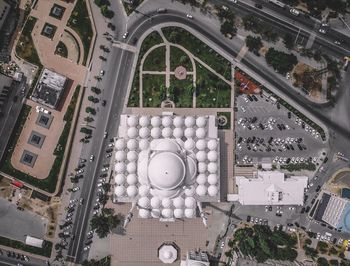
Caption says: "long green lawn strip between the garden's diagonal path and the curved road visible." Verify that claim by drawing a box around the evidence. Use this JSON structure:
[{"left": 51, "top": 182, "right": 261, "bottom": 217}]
[{"left": 162, "top": 27, "right": 232, "bottom": 80}]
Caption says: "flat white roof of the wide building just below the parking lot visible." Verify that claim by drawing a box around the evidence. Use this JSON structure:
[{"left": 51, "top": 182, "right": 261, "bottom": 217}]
[{"left": 236, "top": 171, "right": 308, "bottom": 205}]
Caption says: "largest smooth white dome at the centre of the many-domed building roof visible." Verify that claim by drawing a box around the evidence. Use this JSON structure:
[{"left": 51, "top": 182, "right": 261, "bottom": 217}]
[{"left": 148, "top": 151, "right": 186, "bottom": 190}]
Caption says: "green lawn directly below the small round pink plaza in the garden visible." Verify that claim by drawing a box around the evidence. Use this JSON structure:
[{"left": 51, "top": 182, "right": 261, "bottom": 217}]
[{"left": 170, "top": 75, "right": 193, "bottom": 108}]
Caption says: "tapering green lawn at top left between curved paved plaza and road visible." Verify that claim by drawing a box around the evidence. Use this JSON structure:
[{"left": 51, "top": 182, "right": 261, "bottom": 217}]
[{"left": 67, "top": 0, "right": 93, "bottom": 65}]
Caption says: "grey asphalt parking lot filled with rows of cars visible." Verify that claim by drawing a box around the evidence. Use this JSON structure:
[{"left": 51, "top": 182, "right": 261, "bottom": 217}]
[{"left": 235, "top": 94, "right": 326, "bottom": 165}]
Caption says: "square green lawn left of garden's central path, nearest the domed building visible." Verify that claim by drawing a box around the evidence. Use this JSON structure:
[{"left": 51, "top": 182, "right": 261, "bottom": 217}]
[{"left": 142, "top": 74, "right": 166, "bottom": 107}]
